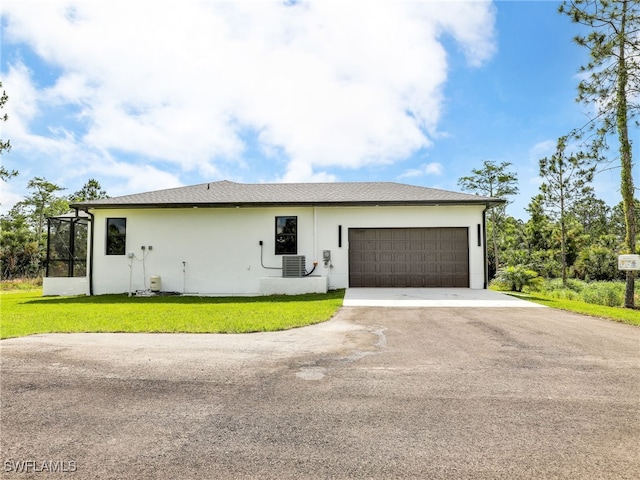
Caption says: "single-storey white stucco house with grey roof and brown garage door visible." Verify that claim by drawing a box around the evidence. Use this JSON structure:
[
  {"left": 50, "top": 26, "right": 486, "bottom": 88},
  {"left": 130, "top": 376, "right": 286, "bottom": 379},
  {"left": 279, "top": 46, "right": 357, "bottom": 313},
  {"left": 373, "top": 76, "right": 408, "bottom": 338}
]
[{"left": 43, "top": 181, "right": 504, "bottom": 295}]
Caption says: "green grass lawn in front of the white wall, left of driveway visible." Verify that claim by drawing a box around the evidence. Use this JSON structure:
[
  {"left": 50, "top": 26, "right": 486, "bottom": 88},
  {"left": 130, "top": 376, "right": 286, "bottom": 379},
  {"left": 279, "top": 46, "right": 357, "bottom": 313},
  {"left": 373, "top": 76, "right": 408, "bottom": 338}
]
[{"left": 0, "top": 290, "right": 344, "bottom": 338}]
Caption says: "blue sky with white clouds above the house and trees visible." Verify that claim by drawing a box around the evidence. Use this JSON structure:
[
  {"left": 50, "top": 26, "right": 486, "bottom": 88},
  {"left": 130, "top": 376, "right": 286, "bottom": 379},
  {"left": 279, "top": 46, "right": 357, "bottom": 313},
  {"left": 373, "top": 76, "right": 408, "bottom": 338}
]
[{"left": 0, "top": 0, "right": 640, "bottom": 218}]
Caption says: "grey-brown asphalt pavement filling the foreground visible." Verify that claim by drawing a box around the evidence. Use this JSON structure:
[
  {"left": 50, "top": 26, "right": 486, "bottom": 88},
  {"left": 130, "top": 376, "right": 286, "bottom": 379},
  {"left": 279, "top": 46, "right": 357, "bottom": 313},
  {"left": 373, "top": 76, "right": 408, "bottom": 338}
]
[{"left": 0, "top": 307, "right": 640, "bottom": 479}]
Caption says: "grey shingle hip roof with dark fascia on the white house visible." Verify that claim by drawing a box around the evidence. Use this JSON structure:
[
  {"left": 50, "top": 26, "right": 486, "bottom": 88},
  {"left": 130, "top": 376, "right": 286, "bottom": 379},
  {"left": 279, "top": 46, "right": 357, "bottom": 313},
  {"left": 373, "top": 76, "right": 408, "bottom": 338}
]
[{"left": 72, "top": 180, "right": 504, "bottom": 208}]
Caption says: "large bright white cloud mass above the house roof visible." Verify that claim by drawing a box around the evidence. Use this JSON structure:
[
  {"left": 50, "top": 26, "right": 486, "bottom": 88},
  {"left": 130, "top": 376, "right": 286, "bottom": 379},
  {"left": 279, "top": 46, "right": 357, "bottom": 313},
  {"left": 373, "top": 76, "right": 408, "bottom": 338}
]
[{"left": 3, "top": 0, "right": 495, "bottom": 193}]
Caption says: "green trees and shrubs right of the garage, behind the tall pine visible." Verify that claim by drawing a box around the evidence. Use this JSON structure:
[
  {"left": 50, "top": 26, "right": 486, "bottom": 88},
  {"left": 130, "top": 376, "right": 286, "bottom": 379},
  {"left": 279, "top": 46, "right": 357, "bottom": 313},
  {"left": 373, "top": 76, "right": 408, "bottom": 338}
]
[{"left": 458, "top": 159, "right": 640, "bottom": 283}]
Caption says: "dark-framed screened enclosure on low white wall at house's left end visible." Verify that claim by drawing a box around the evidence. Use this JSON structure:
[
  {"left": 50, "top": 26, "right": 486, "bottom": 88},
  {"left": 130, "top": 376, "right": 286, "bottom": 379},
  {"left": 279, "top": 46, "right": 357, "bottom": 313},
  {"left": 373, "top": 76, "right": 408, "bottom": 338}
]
[{"left": 43, "top": 212, "right": 90, "bottom": 295}]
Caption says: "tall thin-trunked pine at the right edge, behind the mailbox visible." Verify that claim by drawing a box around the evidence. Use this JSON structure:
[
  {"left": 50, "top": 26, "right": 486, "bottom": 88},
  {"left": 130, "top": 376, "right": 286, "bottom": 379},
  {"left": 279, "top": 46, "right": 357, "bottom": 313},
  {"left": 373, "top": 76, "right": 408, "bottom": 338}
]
[{"left": 559, "top": 0, "right": 640, "bottom": 308}]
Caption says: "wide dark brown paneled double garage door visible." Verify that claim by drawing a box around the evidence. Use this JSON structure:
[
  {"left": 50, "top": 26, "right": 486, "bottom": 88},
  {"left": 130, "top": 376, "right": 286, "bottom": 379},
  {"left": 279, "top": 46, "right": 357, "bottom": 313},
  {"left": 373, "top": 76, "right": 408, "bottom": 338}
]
[{"left": 349, "top": 228, "right": 469, "bottom": 287}]
